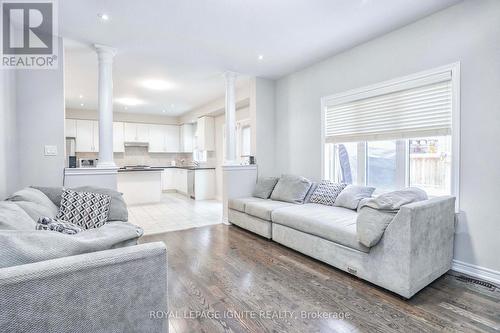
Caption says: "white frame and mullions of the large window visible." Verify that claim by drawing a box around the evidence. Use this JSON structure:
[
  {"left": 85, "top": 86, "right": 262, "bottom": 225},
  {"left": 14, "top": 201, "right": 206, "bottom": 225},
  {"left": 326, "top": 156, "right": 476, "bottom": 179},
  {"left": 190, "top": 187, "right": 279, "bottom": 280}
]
[{"left": 321, "top": 62, "right": 460, "bottom": 208}]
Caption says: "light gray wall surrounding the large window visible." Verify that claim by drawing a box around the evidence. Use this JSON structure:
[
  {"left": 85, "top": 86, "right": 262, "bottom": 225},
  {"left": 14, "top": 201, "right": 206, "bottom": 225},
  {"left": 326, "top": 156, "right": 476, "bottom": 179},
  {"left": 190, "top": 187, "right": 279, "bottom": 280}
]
[{"left": 276, "top": 0, "right": 500, "bottom": 272}]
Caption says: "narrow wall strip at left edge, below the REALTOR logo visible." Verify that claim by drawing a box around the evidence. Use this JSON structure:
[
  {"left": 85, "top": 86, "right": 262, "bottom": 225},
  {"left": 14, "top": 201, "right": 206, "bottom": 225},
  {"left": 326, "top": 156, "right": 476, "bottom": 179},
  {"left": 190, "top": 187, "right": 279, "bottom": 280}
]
[{"left": 0, "top": 69, "right": 18, "bottom": 200}]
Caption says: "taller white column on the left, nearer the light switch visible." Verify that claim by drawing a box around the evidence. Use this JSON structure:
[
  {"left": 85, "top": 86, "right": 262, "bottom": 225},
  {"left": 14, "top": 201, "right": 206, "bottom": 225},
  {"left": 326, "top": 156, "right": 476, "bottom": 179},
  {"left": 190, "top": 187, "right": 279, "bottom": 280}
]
[{"left": 94, "top": 45, "right": 116, "bottom": 168}]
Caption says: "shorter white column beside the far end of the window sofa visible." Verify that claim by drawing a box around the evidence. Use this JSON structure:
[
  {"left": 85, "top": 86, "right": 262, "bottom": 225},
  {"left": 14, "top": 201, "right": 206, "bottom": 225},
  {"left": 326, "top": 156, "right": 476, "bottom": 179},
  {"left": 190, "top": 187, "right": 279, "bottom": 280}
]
[{"left": 224, "top": 72, "right": 236, "bottom": 165}]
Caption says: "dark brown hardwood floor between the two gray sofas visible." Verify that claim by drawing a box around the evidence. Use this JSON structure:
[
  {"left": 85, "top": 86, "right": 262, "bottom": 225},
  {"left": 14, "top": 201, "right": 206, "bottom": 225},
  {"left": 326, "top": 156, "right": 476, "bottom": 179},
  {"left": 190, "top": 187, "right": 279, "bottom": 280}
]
[{"left": 142, "top": 224, "right": 500, "bottom": 333}]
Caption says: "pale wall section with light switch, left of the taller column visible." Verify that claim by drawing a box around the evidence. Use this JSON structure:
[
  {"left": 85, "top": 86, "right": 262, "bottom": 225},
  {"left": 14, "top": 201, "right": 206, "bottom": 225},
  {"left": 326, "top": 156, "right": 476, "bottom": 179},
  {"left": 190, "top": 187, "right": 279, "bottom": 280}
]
[{"left": 16, "top": 39, "right": 65, "bottom": 187}]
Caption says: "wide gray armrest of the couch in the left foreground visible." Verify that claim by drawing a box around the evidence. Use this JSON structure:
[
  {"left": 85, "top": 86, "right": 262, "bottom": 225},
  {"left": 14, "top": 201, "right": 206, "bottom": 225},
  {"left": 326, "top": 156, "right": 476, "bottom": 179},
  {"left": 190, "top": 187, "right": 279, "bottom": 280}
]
[{"left": 0, "top": 242, "right": 168, "bottom": 333}]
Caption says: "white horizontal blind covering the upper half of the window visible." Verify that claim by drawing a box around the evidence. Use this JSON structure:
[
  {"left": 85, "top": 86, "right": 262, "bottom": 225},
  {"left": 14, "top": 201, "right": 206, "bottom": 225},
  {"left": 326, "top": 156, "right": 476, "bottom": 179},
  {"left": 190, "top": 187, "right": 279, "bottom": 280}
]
[{"left": 323, "top": 71, "right": 452, "bottom": 143}]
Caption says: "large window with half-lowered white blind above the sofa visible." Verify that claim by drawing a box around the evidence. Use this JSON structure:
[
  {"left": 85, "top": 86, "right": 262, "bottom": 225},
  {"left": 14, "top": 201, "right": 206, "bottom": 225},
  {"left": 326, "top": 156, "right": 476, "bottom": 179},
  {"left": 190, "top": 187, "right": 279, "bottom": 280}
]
[{"left": 322, "top": 65, "right": 459, "bottom": 201}]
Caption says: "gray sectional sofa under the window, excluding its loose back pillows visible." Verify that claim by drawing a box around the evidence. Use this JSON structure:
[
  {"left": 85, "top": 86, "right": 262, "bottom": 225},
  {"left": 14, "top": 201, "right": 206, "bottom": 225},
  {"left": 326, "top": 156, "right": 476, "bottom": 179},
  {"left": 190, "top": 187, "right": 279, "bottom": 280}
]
[{"left": 228, "top": 175, "right": 455, "bottom": 298}]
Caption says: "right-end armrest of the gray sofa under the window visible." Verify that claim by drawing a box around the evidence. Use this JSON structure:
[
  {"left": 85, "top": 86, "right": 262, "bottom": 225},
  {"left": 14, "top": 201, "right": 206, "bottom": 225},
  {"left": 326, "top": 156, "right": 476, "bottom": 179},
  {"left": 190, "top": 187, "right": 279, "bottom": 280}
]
[{"left": 378, "top": 197, "right": 455, "bottom": 297}]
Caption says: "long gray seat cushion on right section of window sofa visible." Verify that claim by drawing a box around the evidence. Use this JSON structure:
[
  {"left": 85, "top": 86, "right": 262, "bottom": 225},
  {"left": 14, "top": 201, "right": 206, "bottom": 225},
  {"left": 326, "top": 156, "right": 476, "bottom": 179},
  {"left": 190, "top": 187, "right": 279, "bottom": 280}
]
[{"left": 272, "top": 203, "right": 369, "bottom": 252}]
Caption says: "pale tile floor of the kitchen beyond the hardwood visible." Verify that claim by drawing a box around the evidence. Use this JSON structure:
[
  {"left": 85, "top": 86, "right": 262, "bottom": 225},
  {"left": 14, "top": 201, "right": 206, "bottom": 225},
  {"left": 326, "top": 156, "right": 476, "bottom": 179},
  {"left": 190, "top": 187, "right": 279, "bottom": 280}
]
[{"left": 128, "top": 193, "right": 222, "bottom": 235}]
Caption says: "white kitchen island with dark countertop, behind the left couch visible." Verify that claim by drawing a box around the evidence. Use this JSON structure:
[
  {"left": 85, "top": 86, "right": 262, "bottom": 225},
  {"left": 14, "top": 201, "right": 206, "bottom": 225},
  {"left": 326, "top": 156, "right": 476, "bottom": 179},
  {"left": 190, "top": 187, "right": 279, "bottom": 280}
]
[{"left": 118, "top": 168, "right": 163, "bottom": 205}]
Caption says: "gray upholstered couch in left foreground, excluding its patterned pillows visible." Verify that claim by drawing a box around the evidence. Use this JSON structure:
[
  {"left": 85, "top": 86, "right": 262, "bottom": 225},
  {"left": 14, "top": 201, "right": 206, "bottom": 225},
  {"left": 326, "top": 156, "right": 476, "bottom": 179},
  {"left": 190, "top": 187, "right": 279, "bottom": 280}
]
[{"left": 0, "top": 188, "right": 168, "bottom": 332}]
